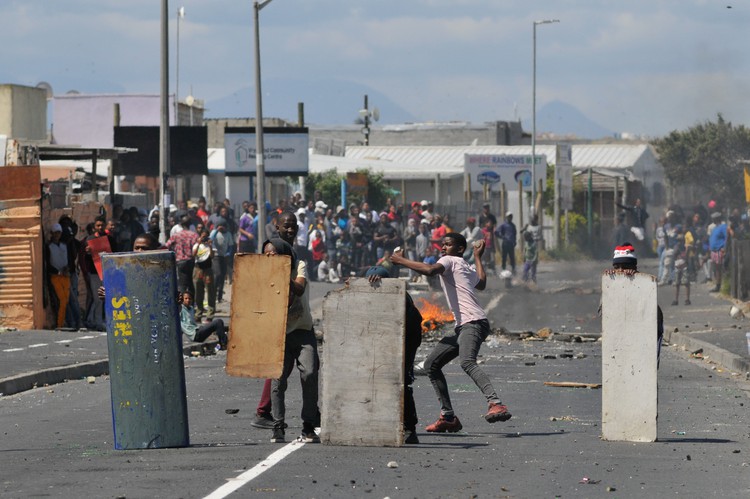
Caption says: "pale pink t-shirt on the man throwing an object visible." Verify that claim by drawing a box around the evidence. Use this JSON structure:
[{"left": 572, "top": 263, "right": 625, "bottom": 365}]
[{"left": 437, "top": 255, "right": 487, "bottom": 326}]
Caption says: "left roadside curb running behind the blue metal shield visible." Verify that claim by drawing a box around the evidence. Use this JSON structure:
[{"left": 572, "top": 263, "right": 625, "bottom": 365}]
[{"left": 0, "top": 341, "right": 218, "bottom": 397}]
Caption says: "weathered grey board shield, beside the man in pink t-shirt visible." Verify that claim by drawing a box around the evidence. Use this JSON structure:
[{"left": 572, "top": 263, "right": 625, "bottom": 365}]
[{"left": 320, "top": 279, "right": 406, "bottom": 446}]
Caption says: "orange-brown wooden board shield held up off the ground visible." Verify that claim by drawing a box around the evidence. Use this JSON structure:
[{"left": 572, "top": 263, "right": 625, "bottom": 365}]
[{"left": 227, "top": 253, "right": 292, "bottom": 378}]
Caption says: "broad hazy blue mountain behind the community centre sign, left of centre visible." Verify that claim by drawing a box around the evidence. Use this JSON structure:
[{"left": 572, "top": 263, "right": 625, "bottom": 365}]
[{"left": 206, "top": 79, "right": 416, "bottom": 124}]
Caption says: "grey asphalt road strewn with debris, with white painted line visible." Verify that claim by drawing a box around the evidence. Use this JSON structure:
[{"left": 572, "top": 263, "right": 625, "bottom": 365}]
[{"left": 0, "top": 260, "right": 750, "bottom": 498}]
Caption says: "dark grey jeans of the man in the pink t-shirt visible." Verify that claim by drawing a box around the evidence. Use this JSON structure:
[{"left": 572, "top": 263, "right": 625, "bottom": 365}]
[{"left": 424, "top": 319, "right": 500, "bottom": 416}]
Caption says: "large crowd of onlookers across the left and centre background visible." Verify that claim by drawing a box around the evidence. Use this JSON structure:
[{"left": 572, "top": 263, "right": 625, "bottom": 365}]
[{"left": 45, "top": 191, "right": 541, "bottom": 330}]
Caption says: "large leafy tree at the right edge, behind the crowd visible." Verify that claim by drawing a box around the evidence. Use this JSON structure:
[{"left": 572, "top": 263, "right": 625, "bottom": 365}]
[{"left": 652, "top": 114, "right": 750, "bottom": 205}]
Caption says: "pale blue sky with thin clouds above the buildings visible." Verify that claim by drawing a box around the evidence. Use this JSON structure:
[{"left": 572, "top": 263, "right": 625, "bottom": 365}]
[{"left": 0, "top": 0, "right": 750, "bottom": 137}]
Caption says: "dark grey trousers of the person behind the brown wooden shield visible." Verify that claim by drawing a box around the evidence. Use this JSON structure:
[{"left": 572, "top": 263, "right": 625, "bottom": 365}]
[{"left": 271, "top": 329, "right": 320, "bottom": 424}]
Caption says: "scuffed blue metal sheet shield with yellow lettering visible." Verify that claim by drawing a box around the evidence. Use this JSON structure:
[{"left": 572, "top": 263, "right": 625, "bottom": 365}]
[{"left": 102, "top": 251, "right": 190, "bottom": 449}]
